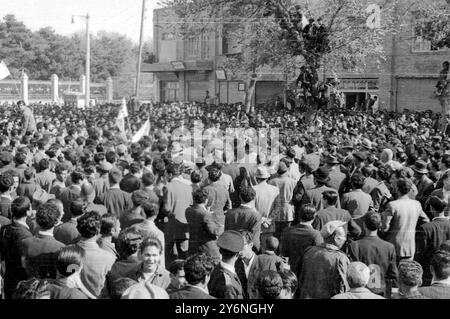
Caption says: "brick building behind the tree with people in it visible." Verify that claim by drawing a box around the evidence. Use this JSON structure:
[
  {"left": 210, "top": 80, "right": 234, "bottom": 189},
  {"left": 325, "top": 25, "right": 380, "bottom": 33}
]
[{"left": 143, "top": 4, "right": 450, "bottom": 111}]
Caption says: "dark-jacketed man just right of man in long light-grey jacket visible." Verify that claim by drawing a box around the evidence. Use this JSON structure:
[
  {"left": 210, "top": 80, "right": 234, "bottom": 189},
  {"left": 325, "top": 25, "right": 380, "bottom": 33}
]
[{"left": 186, "top": 189, "right": 223, "bottom": 264}]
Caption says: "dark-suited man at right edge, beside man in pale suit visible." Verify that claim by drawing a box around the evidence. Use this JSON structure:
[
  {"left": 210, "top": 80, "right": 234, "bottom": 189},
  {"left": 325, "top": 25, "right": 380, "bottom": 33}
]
[{"left": 415, "top": 197, "right": 450, "bottom": 286}]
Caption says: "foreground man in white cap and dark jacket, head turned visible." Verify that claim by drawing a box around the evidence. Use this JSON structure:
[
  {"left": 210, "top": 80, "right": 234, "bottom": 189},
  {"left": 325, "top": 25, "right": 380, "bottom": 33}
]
[{"left": 297, "top": 221, "right": 350, "bottom": 299}]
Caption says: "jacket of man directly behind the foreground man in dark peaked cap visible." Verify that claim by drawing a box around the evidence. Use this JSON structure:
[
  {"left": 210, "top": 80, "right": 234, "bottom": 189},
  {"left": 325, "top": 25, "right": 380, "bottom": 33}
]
[{"left": 225, "top": 205, "right": 261, "bottom": 251}]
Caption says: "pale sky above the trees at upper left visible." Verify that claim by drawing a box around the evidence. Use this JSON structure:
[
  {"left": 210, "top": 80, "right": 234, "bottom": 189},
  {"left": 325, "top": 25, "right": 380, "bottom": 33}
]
[{"left": 0, "top": 0, "right": 159, "bottom": 43}]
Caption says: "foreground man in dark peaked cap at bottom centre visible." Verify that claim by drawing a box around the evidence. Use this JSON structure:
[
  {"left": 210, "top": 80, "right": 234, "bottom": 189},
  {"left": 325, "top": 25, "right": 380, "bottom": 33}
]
[{"left": 208, "top": 230, "right": 244, "bottom": 299}]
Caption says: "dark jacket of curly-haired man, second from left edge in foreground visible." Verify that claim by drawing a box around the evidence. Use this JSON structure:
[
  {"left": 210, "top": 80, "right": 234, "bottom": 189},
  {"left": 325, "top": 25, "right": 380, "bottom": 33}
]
[{"left": 21, "top": 234, "right": 65, "bottom": 279}]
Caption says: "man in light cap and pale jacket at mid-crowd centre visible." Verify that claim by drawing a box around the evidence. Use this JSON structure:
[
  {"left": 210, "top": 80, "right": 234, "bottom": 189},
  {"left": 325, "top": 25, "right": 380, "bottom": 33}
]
[{"left": 253, "top": 166, "right": 280, "bottom": 253}]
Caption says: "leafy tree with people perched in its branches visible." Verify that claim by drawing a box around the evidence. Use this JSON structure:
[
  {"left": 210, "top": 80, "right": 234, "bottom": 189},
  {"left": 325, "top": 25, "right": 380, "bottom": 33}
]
[{"left": 163, "top": 0, "right": 396, "bottom": 111}]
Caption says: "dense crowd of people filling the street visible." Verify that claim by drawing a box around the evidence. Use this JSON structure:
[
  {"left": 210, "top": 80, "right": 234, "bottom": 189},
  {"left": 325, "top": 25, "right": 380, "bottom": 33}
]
[{"left": 0, "top": 97, "right": 450, "bottom": 299}]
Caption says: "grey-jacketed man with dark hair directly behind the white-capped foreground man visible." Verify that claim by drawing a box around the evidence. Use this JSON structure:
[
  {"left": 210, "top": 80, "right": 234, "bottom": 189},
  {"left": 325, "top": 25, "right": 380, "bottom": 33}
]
[{"left": 313, "top": 191, "right": 361, "bottom": 238}]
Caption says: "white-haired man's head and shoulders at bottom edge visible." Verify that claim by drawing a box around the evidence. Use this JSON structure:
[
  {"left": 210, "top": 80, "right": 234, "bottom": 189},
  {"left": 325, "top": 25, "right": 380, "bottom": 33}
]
[{"left": 331, "top": 262, "right": 384, "bottom": 299}]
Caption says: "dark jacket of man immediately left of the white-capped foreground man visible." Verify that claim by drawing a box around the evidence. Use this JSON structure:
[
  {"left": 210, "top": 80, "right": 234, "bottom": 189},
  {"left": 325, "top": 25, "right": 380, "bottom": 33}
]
[{"left": 280, "top": 224, "right": 323, "bottom": 269}]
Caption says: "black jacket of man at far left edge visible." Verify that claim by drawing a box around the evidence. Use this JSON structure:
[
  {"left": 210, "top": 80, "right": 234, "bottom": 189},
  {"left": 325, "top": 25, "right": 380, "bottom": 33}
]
[{"left": 0, "top": 222, "right": 33, "bottom": 298}]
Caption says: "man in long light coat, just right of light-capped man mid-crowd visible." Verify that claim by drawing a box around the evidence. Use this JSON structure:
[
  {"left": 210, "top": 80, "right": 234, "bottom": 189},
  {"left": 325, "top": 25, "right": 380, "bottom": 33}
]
[{"left": 269, "top": 161, "right": 296, "bottom": 238}]
